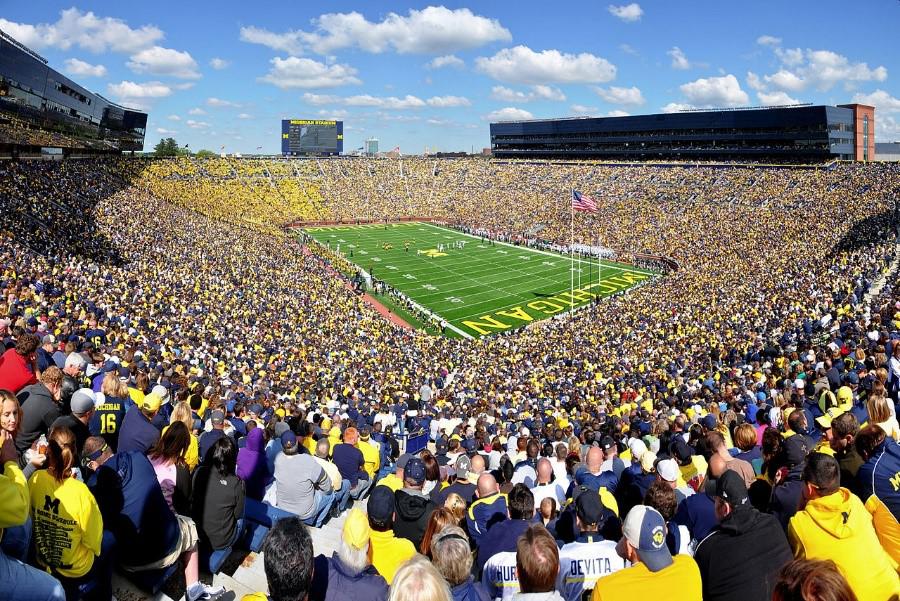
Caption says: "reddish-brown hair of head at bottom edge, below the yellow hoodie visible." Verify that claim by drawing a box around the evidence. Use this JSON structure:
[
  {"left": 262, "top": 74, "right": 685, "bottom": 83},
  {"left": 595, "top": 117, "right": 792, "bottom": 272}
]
[{"left": 772, "top": 559, "right": 858, "bottom": 601}]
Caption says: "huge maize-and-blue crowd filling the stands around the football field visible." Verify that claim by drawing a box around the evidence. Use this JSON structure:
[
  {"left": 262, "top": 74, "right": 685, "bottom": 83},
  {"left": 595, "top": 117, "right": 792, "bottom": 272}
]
[{"left": 0, "top": 158, "right": 900, "bottom": 601}]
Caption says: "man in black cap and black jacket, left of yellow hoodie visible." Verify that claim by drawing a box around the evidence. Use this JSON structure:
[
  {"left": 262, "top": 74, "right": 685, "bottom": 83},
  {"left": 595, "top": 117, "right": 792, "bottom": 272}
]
[{"left": 694, "top": 468, "right": 799, "bottom": 601}]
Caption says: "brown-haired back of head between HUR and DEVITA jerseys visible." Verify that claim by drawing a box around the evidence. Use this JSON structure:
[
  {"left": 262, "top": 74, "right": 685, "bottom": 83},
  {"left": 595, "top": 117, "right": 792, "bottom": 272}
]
[{"left": 512, "top": 524, "right": 563, "bottom": 601}]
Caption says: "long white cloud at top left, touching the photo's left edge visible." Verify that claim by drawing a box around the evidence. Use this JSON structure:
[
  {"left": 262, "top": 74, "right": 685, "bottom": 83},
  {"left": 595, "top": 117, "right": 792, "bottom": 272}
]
[{"left": 0, "top": 8, "right": 163, "bottom": 54}]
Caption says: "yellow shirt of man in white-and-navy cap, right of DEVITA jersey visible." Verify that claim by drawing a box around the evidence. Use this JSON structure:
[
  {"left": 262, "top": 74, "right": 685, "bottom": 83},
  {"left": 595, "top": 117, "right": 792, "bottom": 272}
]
[{"left": 591, "top": 555, "right": 703, "bottom": 601}]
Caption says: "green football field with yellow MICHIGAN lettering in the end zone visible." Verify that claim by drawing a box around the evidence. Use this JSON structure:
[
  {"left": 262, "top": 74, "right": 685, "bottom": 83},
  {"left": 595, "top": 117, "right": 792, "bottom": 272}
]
[{"left": 304, "top": 223, "right": 658, "bottom": 338}]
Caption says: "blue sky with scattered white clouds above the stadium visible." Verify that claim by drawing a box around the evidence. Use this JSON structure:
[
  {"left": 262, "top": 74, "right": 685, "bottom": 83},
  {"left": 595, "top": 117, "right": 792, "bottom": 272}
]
[{"left": 0, "top": 0, "right": 900, "bottom": 154}]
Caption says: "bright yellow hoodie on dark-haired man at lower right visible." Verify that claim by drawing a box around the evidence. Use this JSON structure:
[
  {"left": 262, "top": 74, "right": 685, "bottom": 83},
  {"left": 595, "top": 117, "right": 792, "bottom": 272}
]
[{"left": 788, "top": 488, "right": 900, "bottom": 601}]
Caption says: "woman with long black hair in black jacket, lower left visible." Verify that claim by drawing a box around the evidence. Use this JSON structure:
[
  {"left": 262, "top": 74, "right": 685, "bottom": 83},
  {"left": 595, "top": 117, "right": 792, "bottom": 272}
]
[{"left": 191, "top": 436, "right": 246, "bottom": 551}]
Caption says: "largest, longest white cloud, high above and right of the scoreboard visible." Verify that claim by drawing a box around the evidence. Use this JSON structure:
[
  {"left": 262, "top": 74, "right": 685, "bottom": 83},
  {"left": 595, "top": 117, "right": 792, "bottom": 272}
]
[{"left": 241, "top": 6, "right": 512, "bottom": 54}]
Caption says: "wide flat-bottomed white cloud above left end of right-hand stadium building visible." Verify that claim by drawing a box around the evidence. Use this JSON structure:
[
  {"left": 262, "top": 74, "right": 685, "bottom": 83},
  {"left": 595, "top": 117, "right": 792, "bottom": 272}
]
[{"left": 475, "top": 46, "right": 616, "bottom": 84}]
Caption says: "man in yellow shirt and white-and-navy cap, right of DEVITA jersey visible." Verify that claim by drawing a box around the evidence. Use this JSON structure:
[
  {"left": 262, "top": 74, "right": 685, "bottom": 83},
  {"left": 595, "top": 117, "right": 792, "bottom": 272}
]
[{"left": 591, "top": 505, "right": 703, "bottom": 601}]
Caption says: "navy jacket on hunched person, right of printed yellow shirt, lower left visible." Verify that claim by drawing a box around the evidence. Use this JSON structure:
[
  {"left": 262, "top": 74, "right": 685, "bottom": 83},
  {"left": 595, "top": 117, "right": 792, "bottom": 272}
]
[{"left": 87, "top": 452, "right": 181, "bottom": 567}]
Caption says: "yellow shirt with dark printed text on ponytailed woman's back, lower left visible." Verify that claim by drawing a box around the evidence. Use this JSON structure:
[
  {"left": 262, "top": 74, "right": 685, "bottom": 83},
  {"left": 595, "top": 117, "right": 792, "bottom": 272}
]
[{"left": 28, "top": 470, "right": 103, "bottom": 578}]
